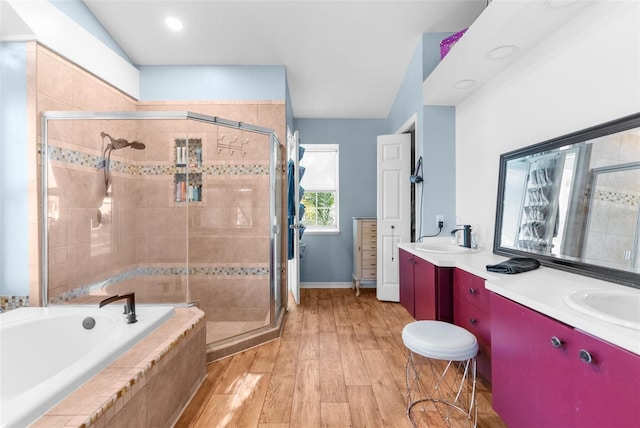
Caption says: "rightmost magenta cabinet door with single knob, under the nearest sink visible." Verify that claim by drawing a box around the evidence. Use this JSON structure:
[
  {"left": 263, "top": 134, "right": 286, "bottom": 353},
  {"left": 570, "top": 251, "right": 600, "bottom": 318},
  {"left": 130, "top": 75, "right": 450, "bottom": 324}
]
[{"left": 572, "top": 330, "right": 640, "bottom": 428}]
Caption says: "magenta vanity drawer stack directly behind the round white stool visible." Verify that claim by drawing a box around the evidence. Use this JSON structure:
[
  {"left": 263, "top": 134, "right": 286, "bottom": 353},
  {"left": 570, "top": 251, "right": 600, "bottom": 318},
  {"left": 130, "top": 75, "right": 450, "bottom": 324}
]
[{"left": 453, "top": 269, "right": 491, "bottom": 382}]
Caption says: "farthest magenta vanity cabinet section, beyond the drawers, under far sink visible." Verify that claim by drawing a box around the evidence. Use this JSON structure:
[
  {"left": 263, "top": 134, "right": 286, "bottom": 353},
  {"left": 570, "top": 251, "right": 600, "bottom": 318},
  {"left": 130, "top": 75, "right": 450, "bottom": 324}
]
[{"left": 398, "top": 249, "right": 453, "bottom": 322}]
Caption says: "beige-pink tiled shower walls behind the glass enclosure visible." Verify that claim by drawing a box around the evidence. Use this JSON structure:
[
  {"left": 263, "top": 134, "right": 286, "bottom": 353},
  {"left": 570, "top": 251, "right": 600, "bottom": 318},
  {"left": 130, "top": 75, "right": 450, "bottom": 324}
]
[{"left": 23, "top": 44, "right": 285, "bottom": 320}]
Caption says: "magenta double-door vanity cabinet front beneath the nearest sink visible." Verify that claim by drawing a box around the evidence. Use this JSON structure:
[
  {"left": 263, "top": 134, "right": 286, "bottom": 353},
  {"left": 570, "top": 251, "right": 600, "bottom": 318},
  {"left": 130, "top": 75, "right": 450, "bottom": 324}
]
[{"left": 491, "top": 294, "right": 640, "bottom": 428}]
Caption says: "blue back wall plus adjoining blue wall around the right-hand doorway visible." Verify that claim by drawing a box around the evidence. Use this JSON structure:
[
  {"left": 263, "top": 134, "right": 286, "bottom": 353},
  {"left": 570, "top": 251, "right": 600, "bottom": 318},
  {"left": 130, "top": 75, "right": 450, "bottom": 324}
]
[{"left": 294, "top": 33, "right": 455, "bottom": 282}]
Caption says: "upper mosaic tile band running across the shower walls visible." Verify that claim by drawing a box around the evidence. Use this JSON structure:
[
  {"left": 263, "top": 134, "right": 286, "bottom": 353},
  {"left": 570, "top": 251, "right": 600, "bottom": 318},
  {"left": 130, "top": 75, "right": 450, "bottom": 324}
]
[{"left": 45, "top": 145, "right": 269, "bottom": 176}]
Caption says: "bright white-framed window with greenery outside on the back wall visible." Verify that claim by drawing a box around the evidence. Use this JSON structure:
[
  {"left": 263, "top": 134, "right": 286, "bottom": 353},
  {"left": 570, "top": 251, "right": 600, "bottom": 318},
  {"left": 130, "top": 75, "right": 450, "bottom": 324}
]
[{"left": 300, "top": 144, "right": 340, "bottom": 233}]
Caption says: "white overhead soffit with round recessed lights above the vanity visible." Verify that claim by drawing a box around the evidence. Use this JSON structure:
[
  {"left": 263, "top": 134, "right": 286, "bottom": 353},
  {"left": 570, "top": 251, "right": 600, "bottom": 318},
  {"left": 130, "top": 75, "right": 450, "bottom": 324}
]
[{"left": 422, "top": 0, "right": 592, "bottom": 106}]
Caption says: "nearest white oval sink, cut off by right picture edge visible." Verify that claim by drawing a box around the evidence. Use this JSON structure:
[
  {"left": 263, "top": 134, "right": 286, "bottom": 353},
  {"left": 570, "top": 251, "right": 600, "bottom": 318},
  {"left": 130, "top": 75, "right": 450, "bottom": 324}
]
[{"left": 565, "top": 289, "right": 640, "bottom": 330}]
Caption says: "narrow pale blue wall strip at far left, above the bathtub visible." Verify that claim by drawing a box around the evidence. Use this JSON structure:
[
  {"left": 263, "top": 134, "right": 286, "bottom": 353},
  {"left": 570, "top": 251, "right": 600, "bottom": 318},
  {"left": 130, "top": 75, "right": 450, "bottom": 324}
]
[{"left": 0, "top": 42, "right": 29, "bottom": 296}]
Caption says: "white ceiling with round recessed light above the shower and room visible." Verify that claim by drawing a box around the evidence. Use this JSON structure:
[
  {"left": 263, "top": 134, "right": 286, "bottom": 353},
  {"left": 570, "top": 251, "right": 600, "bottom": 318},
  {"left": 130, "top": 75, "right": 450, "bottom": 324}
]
[{"left": 6, "top": 0, "right": 487, "bottom": 118}]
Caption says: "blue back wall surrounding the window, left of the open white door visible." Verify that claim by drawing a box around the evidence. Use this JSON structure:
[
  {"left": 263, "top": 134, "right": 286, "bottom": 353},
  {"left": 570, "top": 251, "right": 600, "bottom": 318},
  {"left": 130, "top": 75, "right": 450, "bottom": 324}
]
[{"left": 294, "top": 119, "right": 388, "bottom": 282}]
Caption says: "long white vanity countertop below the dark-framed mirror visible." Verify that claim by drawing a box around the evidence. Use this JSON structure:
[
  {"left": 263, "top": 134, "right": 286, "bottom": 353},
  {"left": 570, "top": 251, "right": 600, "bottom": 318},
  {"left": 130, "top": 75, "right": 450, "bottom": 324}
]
[{"left": 398, "top": 238, "right": 640, "bottom": 355}]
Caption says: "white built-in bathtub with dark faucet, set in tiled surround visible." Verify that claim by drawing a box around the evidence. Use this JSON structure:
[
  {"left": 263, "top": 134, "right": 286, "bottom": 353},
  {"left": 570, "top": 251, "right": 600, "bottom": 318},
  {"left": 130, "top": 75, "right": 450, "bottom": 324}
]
[{"left": 0, "top": 303, "right": 174, "bottom": 428}]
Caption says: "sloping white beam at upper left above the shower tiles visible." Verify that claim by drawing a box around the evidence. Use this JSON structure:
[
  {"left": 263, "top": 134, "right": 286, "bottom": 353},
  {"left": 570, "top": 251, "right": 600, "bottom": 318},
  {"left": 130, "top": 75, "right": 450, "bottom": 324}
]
[{"left": 7, "top": 0, "right": 140, "bottom": 99}]
